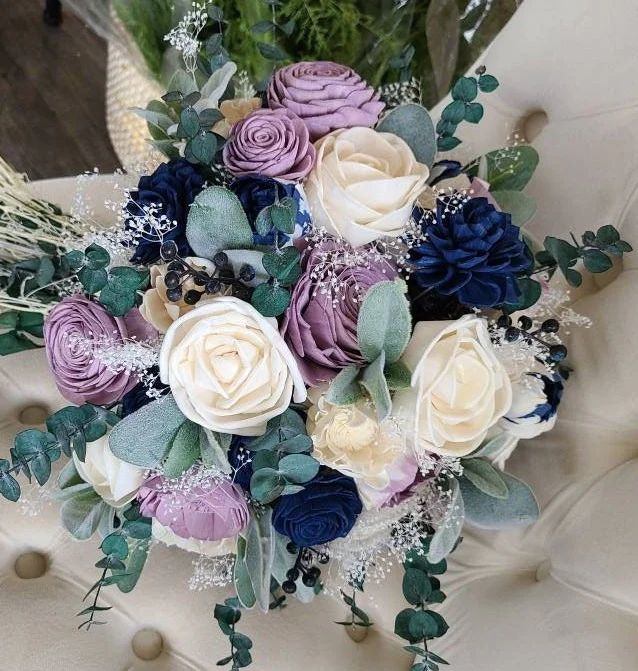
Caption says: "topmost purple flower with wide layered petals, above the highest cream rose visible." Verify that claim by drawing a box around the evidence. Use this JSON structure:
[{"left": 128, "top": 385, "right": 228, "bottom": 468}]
[{"left": 268, "top": 61, "right": 384, "bottom": 142}]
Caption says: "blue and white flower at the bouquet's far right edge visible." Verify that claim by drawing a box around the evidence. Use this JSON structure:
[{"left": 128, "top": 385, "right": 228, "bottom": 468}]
[{"left": 500, "top": 373, "right": 563, "bottom": 438}]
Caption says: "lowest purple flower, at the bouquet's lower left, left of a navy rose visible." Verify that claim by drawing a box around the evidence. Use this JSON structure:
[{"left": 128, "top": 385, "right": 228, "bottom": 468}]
[{"left": 137, "top": 475, "right": 250, "bottom": 541}]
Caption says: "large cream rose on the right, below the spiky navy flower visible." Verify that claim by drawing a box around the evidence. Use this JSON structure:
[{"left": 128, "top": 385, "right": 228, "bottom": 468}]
[{"left": 394, "top": 316, "right": 512, "bottom": 457}]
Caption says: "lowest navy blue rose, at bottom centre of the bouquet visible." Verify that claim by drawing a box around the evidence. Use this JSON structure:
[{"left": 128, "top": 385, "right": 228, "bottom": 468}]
[{"left": 272, "top": 468, "right": 362, "bottom": 547}]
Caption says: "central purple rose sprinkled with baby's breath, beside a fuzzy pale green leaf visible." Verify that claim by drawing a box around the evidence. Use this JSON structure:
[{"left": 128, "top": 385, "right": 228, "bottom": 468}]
[{"left": 281, "top": 241, "right": 396, "bottom": 387}]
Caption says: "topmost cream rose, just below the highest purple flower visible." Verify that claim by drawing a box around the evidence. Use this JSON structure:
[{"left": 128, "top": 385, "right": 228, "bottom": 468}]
[{"left": 305, "top": 127, "right": 429, "bottom": 246}]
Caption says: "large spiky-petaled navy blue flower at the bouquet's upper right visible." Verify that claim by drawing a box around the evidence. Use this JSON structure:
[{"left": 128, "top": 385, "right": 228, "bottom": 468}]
[{"left": 410, "top": 198, "right": 531, "bottom": 307}]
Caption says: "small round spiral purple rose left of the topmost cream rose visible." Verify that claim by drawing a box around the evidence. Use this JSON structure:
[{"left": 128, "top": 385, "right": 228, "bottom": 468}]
[{"left": 224, "top": 109, "right": 315, "bottom": 181}]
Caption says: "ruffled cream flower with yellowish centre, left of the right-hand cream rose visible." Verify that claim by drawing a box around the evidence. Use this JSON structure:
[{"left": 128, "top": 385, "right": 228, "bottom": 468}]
[{"left": 306, "top": 387, "right": 416, "bottom": 508}]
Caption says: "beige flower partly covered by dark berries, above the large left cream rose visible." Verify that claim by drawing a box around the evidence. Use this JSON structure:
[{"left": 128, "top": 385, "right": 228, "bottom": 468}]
[{"left": 140, "top": 256, "right": 220, "bottom": 333}]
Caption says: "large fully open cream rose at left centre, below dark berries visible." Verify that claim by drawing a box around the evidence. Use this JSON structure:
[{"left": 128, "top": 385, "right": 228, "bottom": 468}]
[{"left": 160, "top": 296, "right": 306, "bottom": 436}]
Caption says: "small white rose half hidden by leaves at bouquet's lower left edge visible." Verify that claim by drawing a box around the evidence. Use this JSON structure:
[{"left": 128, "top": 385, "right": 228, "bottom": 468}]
[{"left": 73, "top": 434, "right": 145, "bottom": 508}]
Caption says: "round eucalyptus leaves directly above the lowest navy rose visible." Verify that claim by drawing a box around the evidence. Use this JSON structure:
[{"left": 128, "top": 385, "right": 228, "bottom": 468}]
[{"left": 246, "top": 409, "right": 319, "bottom": 504}]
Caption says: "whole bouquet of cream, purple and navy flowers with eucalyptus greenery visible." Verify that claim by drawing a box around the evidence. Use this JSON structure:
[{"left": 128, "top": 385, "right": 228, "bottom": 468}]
[{"left": 0, "top": 6, "right": 631, "bottom": 671}]
